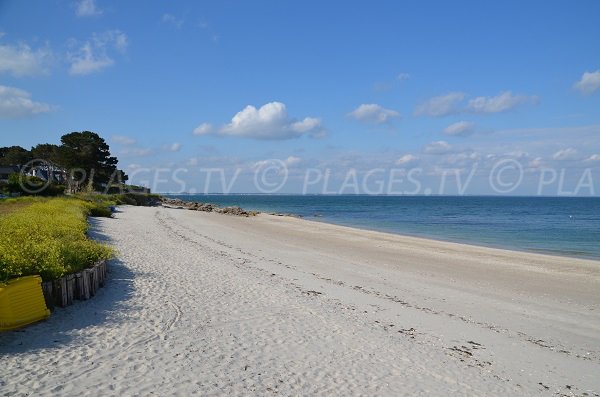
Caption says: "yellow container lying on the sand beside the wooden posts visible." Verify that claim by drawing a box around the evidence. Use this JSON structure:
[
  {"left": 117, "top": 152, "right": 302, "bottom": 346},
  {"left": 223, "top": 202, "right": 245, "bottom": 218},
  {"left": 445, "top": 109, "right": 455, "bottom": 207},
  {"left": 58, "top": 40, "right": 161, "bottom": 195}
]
[{"left": 0, "top": 276, "right": 50, "bottom": 331}]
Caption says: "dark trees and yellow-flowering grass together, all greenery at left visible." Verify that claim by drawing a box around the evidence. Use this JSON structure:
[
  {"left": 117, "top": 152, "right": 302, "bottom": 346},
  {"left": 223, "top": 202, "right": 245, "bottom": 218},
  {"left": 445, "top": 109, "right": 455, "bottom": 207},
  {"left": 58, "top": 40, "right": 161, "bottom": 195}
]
[{"left": 0, "top": 131, "right": 160, "bottom": 282}]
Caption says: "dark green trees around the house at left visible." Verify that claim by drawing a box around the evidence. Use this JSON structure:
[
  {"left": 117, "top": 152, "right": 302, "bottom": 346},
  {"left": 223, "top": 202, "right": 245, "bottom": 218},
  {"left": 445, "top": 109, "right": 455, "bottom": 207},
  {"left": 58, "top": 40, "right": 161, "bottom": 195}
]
[{"left": 0, "top": 131, "right": 128, "bottom": 193}]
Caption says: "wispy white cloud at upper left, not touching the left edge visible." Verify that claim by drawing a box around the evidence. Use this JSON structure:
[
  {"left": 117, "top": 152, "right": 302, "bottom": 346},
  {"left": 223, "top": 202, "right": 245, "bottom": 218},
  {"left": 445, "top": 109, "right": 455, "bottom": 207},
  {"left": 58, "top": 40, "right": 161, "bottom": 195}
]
[{"left": 68, "top": 30, "right": 129, "bottom": 75}]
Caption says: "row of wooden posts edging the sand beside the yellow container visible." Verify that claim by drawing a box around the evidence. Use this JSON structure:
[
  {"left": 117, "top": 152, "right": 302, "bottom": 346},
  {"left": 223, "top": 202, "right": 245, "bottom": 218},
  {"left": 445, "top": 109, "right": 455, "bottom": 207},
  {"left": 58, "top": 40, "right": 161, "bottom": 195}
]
[{"left": 42, "top": 261, "right": 108, "bottom": 309}]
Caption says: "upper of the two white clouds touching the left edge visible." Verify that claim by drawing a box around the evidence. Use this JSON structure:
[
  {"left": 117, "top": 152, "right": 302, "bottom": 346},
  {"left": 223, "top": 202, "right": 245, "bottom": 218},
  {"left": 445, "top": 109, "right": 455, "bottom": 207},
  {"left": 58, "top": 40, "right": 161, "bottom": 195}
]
[{"left": 0, "top": 44, "right": 52, "bottom": 77}]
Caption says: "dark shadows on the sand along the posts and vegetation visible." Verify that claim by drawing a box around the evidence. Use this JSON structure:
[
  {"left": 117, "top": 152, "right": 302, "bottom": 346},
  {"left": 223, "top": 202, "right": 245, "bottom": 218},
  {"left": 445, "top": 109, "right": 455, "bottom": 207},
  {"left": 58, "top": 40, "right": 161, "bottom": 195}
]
[{"left": 0, "top": 213, "right": 137, "bottom": 352}]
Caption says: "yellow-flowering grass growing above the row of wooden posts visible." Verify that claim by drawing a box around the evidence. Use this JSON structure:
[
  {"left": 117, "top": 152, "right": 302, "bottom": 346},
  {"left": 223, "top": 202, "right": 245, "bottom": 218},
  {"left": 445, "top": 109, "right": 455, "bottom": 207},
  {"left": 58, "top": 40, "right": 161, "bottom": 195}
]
[{"left": 0, "top": 197, "right": 113, "bottom": 281}]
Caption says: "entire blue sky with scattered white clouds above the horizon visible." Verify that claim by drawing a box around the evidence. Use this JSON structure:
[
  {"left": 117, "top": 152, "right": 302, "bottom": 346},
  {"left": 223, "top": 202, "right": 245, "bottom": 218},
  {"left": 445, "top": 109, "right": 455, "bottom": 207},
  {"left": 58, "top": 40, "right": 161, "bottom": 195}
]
[{"left": 0, "top": 0, "right": 600, "bottom": 195}]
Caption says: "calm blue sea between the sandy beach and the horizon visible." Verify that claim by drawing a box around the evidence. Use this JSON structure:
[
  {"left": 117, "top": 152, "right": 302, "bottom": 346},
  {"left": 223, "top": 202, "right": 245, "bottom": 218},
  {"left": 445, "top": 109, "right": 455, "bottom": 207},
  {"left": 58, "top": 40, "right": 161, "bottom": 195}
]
[{"left": 166, "top": 195, "right": 600, "bottom": 259}]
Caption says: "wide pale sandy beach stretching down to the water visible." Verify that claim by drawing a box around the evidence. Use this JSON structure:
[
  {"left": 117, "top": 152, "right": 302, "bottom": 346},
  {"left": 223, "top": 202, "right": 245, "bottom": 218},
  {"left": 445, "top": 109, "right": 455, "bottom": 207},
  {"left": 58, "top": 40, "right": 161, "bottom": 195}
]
[{"left": 0, "top": 206, "right": 600, "bottom": 396}]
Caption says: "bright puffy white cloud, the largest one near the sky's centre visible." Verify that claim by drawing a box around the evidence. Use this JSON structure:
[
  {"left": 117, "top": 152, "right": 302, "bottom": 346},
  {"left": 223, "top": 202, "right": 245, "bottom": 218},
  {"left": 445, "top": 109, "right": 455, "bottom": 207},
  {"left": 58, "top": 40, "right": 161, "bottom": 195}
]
[{"left": 213, "top": 102, "right": 325, "bottom": 139}]
